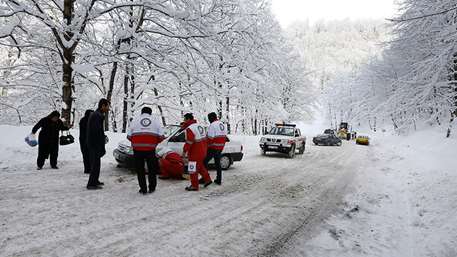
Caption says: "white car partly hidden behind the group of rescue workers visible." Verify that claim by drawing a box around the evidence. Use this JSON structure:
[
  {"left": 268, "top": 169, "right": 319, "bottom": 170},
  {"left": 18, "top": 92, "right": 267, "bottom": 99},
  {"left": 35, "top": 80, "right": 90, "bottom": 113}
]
[{"left": 113, "top": 125, "right": 243, "bottom": 170}]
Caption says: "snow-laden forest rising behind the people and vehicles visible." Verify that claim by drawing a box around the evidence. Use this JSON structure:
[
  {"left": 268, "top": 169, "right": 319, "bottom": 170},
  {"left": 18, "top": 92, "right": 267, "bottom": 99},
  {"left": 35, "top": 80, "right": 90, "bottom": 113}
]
[{"left": 0, "top": 0, "right": 457, "bottom": 135}]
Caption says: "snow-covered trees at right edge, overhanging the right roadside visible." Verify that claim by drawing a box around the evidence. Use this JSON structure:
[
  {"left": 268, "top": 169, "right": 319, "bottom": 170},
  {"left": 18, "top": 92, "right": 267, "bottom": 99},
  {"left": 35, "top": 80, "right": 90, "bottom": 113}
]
[{"left": 326, "top": 0, "right": 457, "bottom": 132}]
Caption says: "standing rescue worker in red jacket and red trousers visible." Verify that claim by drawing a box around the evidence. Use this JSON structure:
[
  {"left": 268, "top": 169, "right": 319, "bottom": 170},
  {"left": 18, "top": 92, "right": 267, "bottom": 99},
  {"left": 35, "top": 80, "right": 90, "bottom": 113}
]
[{"left": 183, "top": 113, "right": 213, "bottom": 191}]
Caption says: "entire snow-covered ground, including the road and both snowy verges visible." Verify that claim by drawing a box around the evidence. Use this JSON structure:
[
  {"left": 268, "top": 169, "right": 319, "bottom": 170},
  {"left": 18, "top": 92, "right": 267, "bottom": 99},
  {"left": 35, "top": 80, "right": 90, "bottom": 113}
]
[{"left": 0, "top": 126, "right": 457, "bottom": 257}]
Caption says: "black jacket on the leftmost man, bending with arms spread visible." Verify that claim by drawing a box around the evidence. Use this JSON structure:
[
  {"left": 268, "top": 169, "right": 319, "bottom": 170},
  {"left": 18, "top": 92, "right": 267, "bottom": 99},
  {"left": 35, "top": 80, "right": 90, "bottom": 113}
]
[{"left": 32, "top": 116, "right": 69, "bottom": 145}]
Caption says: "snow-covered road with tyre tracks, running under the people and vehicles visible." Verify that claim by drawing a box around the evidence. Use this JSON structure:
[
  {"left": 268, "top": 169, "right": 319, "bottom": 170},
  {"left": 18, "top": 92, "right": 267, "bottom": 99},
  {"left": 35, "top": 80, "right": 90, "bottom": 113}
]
[{"left": 0, "top": 126, "right": 370, "bottom": 256}]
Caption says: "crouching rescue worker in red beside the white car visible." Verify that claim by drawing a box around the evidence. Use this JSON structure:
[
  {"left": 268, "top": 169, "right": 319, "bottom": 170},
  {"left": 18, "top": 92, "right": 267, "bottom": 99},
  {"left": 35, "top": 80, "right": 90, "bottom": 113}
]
[{"left": 157, "top": 148, "right": 184, "bottom": 179}]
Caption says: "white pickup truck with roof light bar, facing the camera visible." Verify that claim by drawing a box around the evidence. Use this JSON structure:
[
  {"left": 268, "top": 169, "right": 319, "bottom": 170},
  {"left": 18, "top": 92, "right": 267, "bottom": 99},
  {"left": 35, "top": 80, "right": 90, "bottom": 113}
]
[{"left": 259, "top": 124, "right": 306, "bottom": 158}]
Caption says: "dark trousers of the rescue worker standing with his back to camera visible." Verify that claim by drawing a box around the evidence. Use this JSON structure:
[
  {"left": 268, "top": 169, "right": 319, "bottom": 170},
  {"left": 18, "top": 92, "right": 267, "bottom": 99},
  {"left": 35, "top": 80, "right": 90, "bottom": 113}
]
[{"left": 133, "top": 150, "right": 159, "bottom": 192}]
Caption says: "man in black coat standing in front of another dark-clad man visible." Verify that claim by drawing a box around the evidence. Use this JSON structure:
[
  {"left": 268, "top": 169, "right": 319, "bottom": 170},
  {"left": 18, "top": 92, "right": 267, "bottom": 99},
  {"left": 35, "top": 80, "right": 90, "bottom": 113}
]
[{"left": 86, "top": 98, "right": 110, "bottom": 190}]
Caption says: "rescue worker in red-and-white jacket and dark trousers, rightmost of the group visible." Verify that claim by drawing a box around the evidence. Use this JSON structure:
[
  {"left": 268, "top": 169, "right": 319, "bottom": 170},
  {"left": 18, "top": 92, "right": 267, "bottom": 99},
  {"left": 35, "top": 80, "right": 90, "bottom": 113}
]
[{"left": 205, "top": 112, "right": 227, "bottom": 185}]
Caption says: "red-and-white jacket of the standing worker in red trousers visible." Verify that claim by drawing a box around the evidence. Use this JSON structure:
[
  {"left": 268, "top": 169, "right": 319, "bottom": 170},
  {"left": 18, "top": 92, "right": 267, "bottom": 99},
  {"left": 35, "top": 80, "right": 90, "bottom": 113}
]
[{"left": 183, "top": 120, "right": 207, "bottom": 161}]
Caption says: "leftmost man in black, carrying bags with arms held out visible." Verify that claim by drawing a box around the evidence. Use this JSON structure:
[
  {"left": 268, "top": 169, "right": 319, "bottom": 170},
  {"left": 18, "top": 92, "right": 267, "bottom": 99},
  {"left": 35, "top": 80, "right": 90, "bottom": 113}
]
[{"left": 32, "top": 111, "right": 70, "bottom": 170}]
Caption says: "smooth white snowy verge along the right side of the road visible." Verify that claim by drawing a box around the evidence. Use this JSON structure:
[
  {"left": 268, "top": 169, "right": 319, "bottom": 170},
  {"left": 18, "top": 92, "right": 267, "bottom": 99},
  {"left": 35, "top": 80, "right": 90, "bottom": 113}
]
[{"left": 296, "top": 130, "right": 457, "bottom": 257}]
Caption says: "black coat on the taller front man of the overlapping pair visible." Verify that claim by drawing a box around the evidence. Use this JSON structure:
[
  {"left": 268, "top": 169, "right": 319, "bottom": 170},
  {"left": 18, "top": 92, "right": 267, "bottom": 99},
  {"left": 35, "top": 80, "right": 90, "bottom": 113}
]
[{"left": 86, "top": 110, "right": 106, "bottom": 157}]
